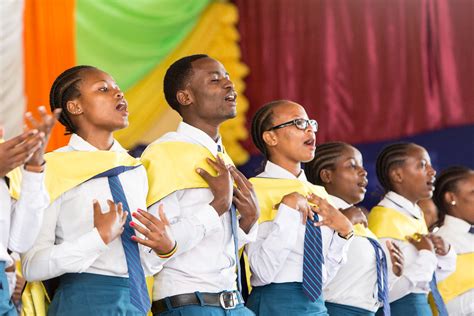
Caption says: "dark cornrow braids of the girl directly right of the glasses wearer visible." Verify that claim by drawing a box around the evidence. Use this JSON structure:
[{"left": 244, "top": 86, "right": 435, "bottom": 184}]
[{"left": 304, "top": 142, "right": 350, "bottom": 186}]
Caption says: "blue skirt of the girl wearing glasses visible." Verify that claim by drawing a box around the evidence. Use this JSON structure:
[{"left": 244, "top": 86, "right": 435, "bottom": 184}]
[{"left": 247, "top": 282, "right": 328, "bottom": 316}]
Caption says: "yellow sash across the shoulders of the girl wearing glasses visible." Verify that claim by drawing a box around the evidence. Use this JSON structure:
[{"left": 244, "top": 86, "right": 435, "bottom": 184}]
[{"left": 250, "top": 178, "right": 328, "bottom": 223}]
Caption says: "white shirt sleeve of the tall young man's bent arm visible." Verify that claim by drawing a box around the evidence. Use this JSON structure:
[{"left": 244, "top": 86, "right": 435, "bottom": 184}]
[{"left": 152, "top": 190, "right": 222, "bottom": 257}]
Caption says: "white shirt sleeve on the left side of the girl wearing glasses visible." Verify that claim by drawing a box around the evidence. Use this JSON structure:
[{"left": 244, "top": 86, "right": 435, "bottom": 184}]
[{"left": 247, "top": 203, "right": 301, "bottom": 284}]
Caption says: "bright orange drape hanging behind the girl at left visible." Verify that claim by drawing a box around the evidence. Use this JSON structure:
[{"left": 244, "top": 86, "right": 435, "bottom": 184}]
[{"left": 24, "top": 0, "right": 76, "bottom": 150}]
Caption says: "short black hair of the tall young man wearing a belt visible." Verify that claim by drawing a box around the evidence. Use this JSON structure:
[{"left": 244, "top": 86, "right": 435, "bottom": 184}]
[{"left": 163, "top": 54, "right": 209, "bottom": 114}]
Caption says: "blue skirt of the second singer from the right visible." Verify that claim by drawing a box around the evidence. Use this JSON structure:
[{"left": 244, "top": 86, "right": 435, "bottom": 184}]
[{"left": 376, "top": 293, "right": 433, "bottom": 316}]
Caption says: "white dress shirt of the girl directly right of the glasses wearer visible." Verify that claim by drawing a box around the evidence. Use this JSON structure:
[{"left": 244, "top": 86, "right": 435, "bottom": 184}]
[{"left": 324, "top": 195, "right": 382, "bottom": 312}]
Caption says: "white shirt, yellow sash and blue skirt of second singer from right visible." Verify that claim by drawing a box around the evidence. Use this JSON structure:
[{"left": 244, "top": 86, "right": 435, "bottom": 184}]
[{"left": 369, "top": 191, "right": 456, "bottom": 316}]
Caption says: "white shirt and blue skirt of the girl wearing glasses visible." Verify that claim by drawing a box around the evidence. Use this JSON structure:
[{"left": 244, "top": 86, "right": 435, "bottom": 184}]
[{"left": 246, "top": 161, "right": 353, "bottom": 315}]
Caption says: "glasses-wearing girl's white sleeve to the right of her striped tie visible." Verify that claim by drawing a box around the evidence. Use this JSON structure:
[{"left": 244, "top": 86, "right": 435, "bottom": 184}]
[{"left": 321, "top": 226, "right": 354, "bottom": 285}]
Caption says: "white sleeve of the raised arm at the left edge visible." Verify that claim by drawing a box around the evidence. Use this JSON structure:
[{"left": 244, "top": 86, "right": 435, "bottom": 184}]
[{"left": 8, "top": 168, "right": 49, "bottom": 253}]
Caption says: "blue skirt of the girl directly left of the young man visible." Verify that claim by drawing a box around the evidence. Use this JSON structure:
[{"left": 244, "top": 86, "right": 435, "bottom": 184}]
[{"left": 48, "top": 273, "right": 145, "bottom": 316}]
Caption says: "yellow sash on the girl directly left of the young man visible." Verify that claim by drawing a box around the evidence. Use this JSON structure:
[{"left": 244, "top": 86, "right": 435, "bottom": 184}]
[{"left": 11, "top": 151, "right": 141, "bottom": 203}]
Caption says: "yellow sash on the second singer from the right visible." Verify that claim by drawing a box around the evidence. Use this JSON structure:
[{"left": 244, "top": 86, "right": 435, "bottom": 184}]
[{"left": 368, "top": 206, "right": 428, "bottom": 241}]
